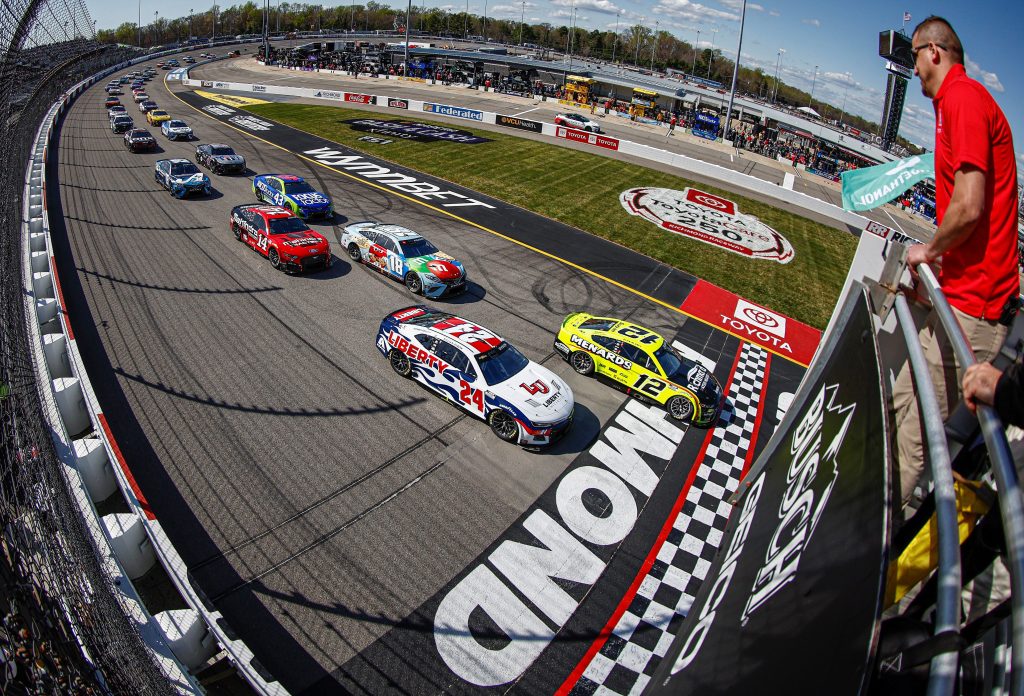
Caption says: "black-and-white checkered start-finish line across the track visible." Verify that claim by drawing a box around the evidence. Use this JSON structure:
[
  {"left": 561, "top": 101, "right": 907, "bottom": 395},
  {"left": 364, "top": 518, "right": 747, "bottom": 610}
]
[{"left": 571, "top": 343, "right": 768, "bottom": 696}]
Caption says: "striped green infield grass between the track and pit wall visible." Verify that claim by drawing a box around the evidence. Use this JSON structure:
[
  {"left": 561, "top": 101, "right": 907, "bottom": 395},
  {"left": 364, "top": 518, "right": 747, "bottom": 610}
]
[{"left": 246, "top": 103, "right": 857, "bottom": 329}]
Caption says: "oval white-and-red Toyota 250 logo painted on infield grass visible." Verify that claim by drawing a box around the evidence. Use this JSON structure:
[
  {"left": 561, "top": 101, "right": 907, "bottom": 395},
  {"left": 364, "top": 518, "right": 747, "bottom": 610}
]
[{"left": 618, "top": 187, "right": 796, "bottom": 263}]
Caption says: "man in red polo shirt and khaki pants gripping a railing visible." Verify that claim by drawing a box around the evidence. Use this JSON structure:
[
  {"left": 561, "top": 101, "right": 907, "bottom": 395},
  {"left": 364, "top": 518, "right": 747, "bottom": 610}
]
[{"left": 893, "top": 16, "right": 1020, "bottom": 505}]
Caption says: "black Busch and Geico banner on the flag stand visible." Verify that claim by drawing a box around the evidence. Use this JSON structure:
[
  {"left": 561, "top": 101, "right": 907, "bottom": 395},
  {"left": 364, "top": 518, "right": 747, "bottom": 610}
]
[{"left": 644, "top": 284, "right": 890, "bottom": 696}]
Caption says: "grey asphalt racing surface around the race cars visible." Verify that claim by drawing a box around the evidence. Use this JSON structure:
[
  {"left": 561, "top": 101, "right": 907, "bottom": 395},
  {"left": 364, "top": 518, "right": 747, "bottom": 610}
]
[{"left": 48, "top": 50, "right": 802, "bottom": 693}]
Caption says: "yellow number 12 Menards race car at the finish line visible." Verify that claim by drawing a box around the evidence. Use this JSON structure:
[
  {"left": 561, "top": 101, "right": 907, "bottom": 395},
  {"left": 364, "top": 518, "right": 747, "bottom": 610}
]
[{"left": 554, "top": 312, "right": 725, "bottom": 426}]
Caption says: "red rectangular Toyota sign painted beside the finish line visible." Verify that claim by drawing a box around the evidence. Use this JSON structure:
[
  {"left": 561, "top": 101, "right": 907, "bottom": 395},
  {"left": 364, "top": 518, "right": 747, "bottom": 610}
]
[{"left": 680, "top": 280, "right": 821, "bottom": 365}]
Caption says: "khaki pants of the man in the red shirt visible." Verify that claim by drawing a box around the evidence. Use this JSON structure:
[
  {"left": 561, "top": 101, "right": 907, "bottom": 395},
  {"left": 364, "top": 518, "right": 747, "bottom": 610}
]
[{"left": 893, "top": 307, "right": 1007, "bottom": 507}]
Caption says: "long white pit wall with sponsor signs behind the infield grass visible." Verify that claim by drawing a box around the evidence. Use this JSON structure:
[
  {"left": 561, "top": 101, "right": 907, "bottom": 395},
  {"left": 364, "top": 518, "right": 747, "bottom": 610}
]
[{"left": 181, "top": 69, "right": 869, "bottom": 230}]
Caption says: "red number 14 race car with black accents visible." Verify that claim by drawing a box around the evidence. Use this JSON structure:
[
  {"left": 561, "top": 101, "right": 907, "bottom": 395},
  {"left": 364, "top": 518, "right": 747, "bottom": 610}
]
[{"left": 231, "top": 204, "right": 333, "bottom": 273}]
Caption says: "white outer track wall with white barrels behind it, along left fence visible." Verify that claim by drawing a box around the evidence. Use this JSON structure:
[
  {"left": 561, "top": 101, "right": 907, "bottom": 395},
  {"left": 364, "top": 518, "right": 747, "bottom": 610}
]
[{"left": 23, "top": 42, "right": 288, "bottom": 696}]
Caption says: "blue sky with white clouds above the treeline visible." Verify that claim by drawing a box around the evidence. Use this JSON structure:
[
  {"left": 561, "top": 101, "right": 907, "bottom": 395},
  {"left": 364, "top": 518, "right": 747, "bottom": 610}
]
[{"left": 87, "top": 0, "right": 1024, "bottom": 177}]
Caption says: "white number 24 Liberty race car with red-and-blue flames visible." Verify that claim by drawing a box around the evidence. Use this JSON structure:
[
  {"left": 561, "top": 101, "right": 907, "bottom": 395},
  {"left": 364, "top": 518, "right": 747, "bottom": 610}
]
[{"left": 377, "top": 305, "right": 575, "bottom": 447}]
